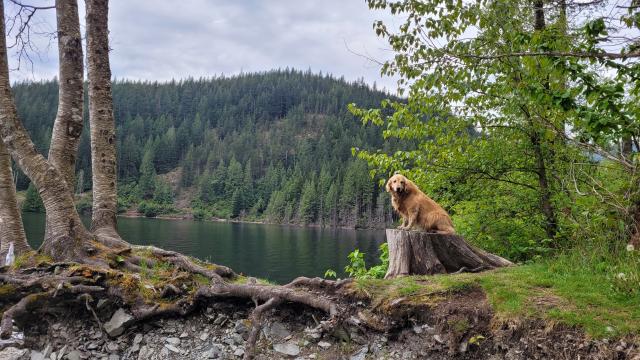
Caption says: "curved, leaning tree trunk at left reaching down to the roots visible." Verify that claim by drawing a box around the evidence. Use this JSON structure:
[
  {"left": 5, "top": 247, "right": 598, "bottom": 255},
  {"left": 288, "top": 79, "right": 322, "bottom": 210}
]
[{"left": 0, "top": 2, "right": 90, "bottom": 260}]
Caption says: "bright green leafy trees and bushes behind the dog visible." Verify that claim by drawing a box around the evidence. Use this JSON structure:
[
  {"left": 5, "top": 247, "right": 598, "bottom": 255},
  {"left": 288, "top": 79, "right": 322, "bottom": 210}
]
[{"left": 356, "top": 0, "right": 640, "bottom": 261}]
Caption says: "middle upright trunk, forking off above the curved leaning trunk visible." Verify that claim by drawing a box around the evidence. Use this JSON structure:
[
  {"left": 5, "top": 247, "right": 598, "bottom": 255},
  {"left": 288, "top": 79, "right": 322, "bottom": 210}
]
[{"left": 49, "top": 0, "right": 84, "bottom": 191}]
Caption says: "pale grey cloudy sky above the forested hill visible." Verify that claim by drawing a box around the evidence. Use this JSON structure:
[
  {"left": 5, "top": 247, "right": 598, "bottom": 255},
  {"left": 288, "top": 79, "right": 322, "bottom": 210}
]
[{"left": 6, "top": 0, "right": 395, "bottom": 91}]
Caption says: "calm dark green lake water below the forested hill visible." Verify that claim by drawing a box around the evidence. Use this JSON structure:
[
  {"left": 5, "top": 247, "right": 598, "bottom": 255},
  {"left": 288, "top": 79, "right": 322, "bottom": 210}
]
[{"left": 22, "top": 213, "right": 385, "bottom": 283}]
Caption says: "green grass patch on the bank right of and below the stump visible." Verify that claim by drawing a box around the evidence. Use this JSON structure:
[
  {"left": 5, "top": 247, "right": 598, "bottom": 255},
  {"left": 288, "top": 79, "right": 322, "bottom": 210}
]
[{"left": 355, "top": 254, "right": 640, "bottom": 338}]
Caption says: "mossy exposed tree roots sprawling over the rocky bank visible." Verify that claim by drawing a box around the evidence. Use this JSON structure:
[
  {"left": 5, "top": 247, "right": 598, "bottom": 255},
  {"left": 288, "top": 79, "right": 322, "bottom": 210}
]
[{"left": 0, "top": 246, "right": 350, "bottom": 359}]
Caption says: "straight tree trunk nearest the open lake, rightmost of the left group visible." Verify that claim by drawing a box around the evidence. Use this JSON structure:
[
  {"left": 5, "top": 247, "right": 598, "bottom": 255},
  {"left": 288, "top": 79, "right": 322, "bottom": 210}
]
[{"left": 86, "top": 0, "right": 117, "bottom": 235}]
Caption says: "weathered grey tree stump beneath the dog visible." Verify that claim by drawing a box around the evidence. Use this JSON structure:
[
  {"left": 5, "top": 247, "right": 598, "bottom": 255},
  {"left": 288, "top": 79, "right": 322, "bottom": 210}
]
[{"left": 385, "top": 229, "right": 513, "bottom": 279}]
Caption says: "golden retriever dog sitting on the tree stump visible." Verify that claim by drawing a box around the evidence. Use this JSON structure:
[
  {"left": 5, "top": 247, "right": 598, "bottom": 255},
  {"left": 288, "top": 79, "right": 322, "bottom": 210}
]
[{"left": 386, "top": 174, "right": 456, "bottom": 234}]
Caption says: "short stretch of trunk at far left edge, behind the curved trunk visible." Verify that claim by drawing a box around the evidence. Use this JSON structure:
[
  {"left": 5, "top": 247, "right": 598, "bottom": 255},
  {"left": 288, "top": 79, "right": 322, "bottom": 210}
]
[{"left": 0, "top": 141, "right": 31, "bottom": 265}]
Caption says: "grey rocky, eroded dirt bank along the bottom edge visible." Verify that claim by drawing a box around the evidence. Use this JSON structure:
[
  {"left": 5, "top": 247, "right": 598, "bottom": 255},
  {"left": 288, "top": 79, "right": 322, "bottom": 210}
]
[{"left": 0, "top": 293, "right": 640, "bottom": 360}]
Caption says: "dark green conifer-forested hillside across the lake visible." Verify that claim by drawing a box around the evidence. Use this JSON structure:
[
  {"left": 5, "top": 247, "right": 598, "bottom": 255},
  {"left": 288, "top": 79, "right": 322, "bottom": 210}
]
[{"left": 14, "top": 70, "right": 393, "bottom": 226}]
